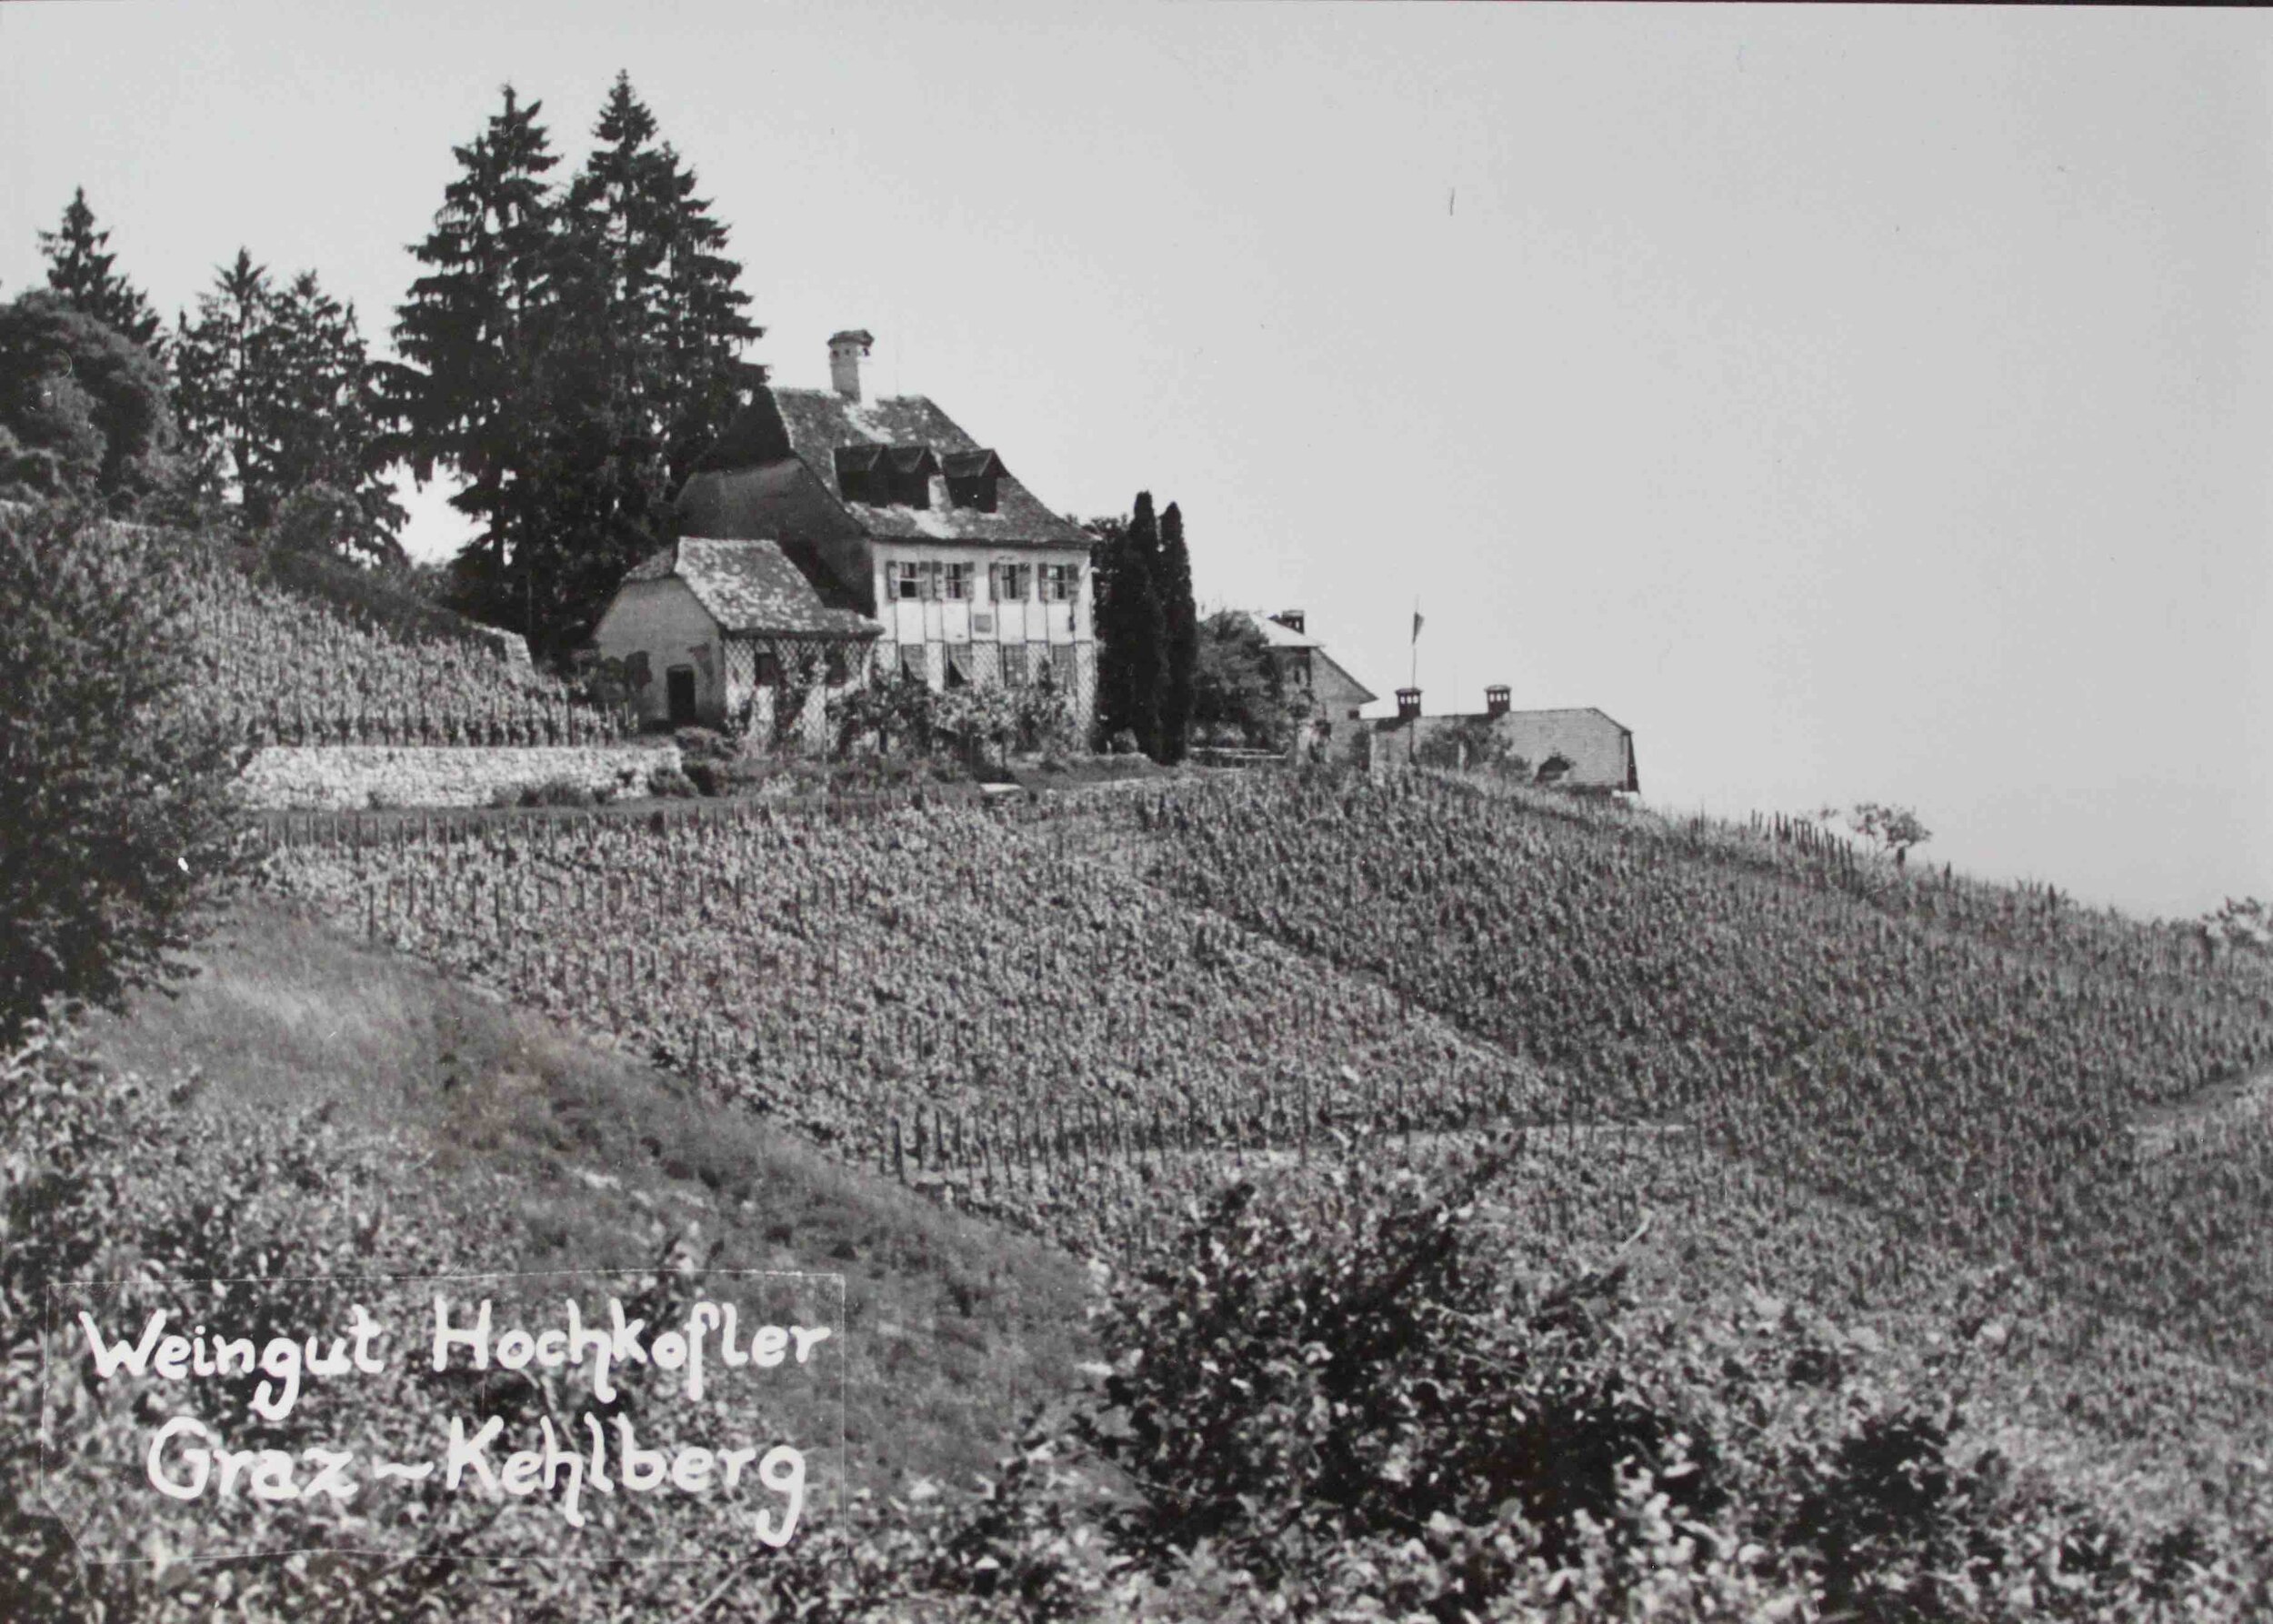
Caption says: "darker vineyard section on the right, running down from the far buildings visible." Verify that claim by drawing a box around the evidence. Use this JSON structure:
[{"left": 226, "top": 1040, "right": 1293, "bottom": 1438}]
[{"left": 1055, "top": 776, "right": 2273, "bottom": 1358}]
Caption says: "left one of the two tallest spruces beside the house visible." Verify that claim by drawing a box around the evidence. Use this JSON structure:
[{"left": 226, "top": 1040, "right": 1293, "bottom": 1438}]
[{"left": 382, "top": 85, "right": 559, "bottom": 627}]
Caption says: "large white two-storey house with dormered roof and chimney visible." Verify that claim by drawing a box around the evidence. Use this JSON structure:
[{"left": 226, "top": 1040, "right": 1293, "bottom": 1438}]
[{"left": 677, "top": 332, "right": 1098, "bottom": 718}]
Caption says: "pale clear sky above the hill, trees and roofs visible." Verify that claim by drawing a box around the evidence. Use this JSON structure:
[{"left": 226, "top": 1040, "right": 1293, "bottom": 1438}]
[{"left": 0, "top": 3, "right": 2273, "bottom": 915}]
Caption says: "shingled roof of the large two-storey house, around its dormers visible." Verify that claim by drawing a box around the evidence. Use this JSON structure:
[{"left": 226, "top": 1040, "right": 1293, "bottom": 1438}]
[{"left": 768, "top": 389, "right": 1089, "bottom": 546}]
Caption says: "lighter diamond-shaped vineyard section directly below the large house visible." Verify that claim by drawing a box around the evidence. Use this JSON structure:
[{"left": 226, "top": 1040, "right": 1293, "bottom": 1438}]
[{"left": 257, "top": 807, "right": 1557, "bottom": 1247}]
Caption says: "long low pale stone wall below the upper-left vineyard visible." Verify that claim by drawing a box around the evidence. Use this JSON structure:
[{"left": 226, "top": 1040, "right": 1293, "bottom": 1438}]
[{"left": 236, "top": 739, "right": 680, "bottom": 809}]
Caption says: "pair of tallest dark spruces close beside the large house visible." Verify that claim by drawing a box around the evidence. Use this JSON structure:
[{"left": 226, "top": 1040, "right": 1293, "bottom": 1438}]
[{"left": 389, "top": 75, "right": 762, "bottom": 653}]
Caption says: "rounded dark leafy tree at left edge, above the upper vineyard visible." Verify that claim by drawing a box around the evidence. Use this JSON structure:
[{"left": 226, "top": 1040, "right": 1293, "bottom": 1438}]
[{"left": 0, "top": 294, "right": 177, "bottom": 514}]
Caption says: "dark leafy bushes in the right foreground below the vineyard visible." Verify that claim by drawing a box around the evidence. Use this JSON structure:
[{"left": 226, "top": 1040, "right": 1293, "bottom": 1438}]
[{"left": 1077, "top": 1142, "right": 2264, "bottom": 1624}]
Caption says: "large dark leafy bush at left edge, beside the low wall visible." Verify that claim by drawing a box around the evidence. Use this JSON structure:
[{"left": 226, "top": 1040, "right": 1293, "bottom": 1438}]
[{"left": 0, "top": 507, "right": 236, "bottom": 1044}]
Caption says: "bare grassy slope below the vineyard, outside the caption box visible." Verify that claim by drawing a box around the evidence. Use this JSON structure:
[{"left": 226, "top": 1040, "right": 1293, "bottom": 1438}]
[{"left": 95, "top": 903, "right": 1094, "bottom": 1489}]
